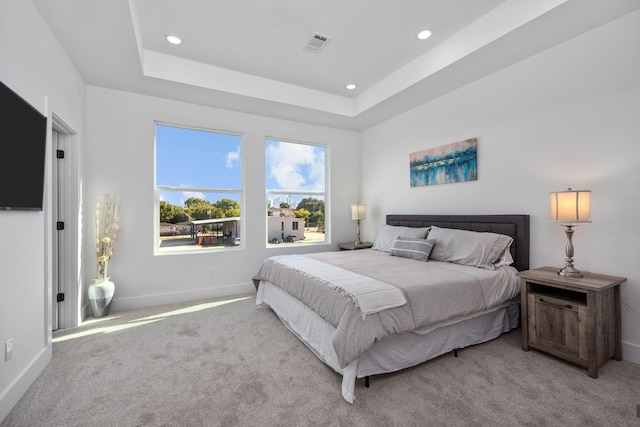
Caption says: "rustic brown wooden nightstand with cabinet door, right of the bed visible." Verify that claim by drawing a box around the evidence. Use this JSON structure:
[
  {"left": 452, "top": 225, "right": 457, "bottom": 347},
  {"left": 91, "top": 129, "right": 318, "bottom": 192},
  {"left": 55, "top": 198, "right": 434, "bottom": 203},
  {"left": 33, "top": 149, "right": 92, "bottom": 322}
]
[{"left": 518, "top": 267, "right": 627, "bottom": 378}]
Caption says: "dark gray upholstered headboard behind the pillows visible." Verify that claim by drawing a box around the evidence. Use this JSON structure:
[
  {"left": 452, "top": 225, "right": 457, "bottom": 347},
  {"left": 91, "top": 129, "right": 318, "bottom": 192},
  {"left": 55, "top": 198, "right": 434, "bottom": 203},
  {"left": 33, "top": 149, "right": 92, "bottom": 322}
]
[{"left": 387, "top": 215, "right": 529, "bottom": 271}]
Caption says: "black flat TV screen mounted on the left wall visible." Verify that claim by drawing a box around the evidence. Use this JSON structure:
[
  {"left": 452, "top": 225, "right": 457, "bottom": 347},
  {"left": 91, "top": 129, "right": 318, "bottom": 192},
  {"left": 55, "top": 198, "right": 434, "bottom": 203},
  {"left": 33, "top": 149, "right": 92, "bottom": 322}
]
[{"left": 0, "top": 82, "right": 47, "bottom": 211}]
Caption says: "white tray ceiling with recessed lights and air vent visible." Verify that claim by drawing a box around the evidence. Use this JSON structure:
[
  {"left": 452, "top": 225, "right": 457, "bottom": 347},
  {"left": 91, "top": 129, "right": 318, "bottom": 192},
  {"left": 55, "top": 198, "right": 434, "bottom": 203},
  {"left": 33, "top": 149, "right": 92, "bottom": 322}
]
[{"left": 32, "top": 0, "right": 640, "bottom": 130}]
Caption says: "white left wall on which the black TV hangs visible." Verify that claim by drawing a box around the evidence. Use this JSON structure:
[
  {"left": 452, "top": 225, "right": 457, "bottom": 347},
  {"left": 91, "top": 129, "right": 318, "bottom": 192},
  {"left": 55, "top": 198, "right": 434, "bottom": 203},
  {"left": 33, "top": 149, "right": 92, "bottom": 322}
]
[{"left": 0, "top": 0, "right": 85, "bottom": 420}]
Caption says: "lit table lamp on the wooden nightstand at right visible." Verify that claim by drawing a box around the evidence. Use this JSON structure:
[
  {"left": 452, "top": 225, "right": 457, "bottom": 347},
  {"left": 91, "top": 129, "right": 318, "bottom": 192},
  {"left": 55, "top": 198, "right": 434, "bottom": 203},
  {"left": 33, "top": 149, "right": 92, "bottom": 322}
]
[{"left": 550, "top": 188, "right": 591, "bottom": 277}]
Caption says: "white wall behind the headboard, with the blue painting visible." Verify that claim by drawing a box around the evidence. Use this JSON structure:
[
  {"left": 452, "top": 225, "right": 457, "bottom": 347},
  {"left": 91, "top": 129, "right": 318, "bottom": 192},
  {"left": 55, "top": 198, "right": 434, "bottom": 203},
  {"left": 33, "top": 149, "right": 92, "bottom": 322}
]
[{"left": 361, "top": 12, "right": 640, "bottom": 363}]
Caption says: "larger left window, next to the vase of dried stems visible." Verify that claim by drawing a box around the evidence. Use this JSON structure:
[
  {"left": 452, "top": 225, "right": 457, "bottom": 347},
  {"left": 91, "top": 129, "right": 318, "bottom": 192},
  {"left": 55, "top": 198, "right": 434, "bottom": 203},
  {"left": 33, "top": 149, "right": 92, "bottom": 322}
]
[{"left": 155, "top": 124, "right": 242, "bottom": 253}]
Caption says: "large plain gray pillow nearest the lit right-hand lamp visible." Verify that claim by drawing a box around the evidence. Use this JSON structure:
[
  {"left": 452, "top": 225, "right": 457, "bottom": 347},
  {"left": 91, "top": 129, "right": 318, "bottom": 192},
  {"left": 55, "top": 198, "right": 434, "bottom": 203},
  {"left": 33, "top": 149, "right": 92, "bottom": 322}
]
[{"left": 429, "top": 226, "right": 513, "bottom": 270}]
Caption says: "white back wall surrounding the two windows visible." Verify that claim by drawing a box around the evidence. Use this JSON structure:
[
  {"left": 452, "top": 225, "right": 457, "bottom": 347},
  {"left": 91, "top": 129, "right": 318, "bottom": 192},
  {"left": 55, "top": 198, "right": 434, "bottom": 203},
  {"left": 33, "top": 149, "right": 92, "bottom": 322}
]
[{"left": 85, "top": 86, "right": 360, "bottom": 310}]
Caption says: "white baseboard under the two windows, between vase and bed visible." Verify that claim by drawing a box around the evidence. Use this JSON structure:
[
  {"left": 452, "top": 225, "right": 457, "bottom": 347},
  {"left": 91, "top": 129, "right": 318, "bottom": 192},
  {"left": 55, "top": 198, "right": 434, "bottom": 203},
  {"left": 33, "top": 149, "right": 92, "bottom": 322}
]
[{"left": 109, "top": 283, "right": 256, "bottom": 312}]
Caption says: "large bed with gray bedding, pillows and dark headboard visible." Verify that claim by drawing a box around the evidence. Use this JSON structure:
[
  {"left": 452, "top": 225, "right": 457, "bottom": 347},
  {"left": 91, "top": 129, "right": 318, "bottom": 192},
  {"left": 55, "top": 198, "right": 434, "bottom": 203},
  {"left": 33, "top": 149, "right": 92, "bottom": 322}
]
[{"left": 254, "top": 215, "right": 529, "bottom": 403}]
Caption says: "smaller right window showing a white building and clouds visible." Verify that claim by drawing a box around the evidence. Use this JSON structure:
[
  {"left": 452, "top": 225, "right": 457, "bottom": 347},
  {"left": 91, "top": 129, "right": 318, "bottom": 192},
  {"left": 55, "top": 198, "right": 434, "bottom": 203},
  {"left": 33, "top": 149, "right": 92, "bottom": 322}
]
[{"left": 265, "top": 139, "right": 327, "bottom": 246}]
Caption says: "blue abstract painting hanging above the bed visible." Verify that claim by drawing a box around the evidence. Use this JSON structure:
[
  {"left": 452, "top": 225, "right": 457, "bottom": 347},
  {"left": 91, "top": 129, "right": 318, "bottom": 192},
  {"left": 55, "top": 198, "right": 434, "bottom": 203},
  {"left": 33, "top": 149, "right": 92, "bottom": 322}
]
[{"left": 409, "top": 138, "right": 478, "bottom": 187}]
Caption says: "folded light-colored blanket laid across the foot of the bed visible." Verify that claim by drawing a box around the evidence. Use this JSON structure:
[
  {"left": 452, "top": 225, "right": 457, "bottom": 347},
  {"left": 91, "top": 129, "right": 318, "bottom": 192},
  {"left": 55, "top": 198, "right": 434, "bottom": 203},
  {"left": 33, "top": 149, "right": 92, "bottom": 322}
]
[{"left": 264, "top": 255, "right": 407, "bottom": 318}]
